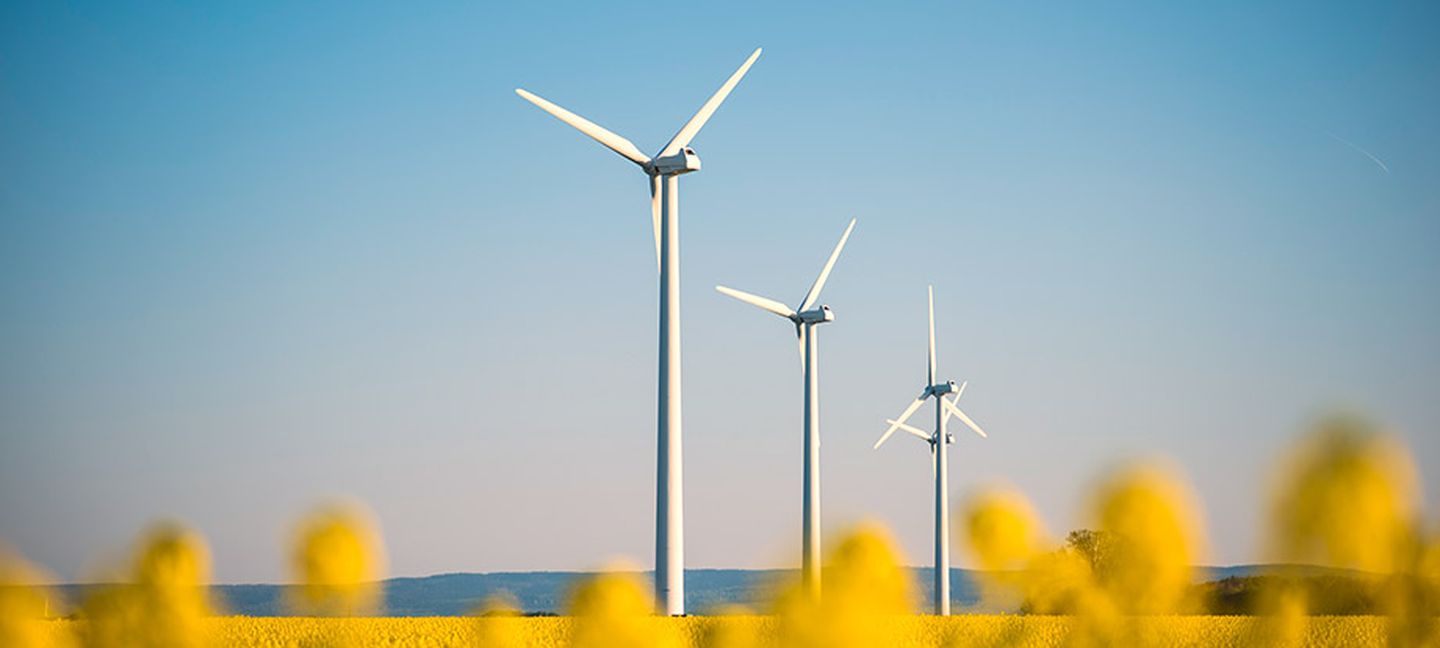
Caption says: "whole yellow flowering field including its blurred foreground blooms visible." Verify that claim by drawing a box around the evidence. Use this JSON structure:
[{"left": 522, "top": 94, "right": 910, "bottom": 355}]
[{"left": 0, "top": 420, "right": 1440, "bottom": 648}]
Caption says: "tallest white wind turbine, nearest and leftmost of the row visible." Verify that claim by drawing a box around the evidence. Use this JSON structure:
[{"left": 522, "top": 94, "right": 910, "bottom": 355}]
[{"left": 516, "top": 48, "right": 760, "bottom": 615}]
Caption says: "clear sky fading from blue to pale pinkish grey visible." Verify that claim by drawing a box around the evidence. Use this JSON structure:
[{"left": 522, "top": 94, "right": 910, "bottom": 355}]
[{"left": 0, "top": 1, "right": 1440, "bottom": 582}]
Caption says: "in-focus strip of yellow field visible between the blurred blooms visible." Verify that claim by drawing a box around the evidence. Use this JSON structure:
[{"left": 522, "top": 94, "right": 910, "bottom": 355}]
[{"left": 11, "top": 615, "right": 1405, "bottom": 648}]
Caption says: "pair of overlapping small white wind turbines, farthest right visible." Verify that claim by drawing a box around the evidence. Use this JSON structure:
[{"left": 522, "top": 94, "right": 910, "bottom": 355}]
[{"left": 876, "top": 287, "right": 985, "bottom": 615}]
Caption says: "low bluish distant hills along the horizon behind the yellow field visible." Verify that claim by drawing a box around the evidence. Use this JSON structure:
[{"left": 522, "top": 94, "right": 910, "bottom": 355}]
[{"left": 47, "top": 564, "right": 1307, "bottom": 616}]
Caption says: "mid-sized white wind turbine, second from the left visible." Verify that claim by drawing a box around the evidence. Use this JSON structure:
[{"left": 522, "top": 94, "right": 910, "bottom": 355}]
[{"left": 716, "top": 219, "right": 855, "bottom": 596}]
